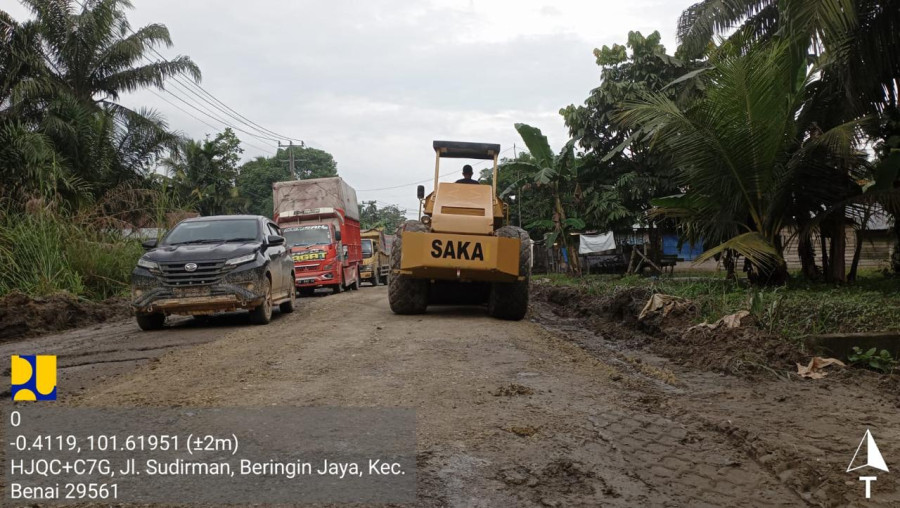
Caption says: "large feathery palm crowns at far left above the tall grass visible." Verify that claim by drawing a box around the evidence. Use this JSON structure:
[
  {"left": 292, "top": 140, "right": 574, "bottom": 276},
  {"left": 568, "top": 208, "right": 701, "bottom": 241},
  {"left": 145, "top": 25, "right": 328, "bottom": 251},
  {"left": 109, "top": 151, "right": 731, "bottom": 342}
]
[{"left": 0, "top": 0, "right": 200, "bottom": 204}]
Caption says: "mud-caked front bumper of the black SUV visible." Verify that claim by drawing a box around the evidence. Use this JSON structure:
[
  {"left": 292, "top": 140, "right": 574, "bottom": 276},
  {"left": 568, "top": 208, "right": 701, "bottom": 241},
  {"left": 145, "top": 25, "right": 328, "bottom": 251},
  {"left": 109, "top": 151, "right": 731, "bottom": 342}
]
[{"left": 131, "top": 268, "right": 266, "bottom": 315}]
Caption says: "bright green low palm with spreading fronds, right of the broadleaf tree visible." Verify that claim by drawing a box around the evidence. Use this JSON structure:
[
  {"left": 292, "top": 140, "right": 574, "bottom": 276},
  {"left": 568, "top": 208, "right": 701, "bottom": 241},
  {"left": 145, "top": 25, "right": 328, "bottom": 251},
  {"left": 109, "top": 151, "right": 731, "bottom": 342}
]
[{"left": 621, "top": 41, "right": 863, "bottom": 283}]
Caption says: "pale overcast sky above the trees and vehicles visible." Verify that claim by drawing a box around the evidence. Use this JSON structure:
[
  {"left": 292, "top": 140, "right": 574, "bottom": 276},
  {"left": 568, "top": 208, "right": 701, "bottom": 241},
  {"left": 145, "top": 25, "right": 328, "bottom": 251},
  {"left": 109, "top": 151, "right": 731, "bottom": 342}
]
[{"left": 0, "top": 0, "right": 694, "bottom": 213}]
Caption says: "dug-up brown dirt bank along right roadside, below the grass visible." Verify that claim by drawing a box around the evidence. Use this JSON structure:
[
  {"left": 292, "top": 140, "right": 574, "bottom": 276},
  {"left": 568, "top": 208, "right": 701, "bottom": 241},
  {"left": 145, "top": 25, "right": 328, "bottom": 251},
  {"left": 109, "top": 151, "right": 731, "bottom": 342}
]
[{"left": 533, "top": 285, "right": 809, "bottom": 374}]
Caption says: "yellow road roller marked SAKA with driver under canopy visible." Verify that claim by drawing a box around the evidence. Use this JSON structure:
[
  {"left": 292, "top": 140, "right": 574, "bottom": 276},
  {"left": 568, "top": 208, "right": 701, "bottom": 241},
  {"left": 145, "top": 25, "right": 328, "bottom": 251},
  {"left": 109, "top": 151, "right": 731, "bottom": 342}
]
[{"left": 388, "top": 141, "right": 531, "bottom": 320}]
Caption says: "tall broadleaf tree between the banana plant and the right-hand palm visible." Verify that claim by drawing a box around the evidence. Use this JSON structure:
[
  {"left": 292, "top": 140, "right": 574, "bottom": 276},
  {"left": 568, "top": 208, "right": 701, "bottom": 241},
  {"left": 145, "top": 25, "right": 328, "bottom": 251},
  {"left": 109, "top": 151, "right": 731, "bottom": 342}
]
[{"left": 560, "top": 32, "right": 701, "bottom": 266}]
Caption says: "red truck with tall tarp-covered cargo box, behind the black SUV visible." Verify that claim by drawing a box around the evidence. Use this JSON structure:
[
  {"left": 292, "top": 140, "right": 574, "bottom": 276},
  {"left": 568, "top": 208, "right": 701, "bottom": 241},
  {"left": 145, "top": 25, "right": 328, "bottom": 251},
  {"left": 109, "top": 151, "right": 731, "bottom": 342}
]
[{"left": 272, "top": 177, "right": 362, "bottom": 296}]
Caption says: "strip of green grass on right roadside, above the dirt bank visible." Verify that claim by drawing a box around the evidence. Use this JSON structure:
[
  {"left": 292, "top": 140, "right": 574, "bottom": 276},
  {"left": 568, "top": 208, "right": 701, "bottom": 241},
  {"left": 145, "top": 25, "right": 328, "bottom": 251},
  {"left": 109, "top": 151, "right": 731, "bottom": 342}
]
[{"left": 536, "top": 271, "right": 900, "bottom": 340}]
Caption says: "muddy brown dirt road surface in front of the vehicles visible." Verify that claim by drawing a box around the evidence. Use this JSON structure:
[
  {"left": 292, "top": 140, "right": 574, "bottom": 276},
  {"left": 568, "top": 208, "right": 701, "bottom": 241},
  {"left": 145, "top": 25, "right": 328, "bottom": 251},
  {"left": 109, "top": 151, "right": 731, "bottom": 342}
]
[{"left": 0, "top": 287, "right": 900, "bottom": 507}]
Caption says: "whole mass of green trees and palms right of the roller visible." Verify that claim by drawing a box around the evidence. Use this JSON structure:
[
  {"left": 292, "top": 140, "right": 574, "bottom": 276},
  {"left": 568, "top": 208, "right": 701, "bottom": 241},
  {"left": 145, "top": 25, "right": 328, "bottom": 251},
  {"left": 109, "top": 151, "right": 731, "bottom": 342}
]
[{"left": 516, "top": 0, "right": 900, "bottom": 284}]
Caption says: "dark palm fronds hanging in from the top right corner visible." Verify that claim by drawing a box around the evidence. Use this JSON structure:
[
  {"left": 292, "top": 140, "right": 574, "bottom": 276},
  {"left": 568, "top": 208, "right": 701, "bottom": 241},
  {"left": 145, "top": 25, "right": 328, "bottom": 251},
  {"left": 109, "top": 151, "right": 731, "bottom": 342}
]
[{"left": 678, "top": 0, "right": 900, "bottom": 112}]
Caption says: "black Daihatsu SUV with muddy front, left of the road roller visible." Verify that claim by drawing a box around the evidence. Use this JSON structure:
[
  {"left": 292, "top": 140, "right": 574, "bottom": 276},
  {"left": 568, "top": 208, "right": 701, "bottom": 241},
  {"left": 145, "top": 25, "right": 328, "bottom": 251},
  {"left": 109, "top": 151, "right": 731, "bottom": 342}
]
[{"left": 131, "top": 215, "right": 295, "bottom": 330}]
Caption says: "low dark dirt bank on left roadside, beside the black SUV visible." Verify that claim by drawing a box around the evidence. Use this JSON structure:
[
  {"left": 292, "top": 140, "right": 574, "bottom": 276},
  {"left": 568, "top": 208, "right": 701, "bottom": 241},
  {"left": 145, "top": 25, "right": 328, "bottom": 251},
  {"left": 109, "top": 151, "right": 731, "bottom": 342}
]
[{"left": 0, "top": 292, "right": 131, "bottom": 342}]
